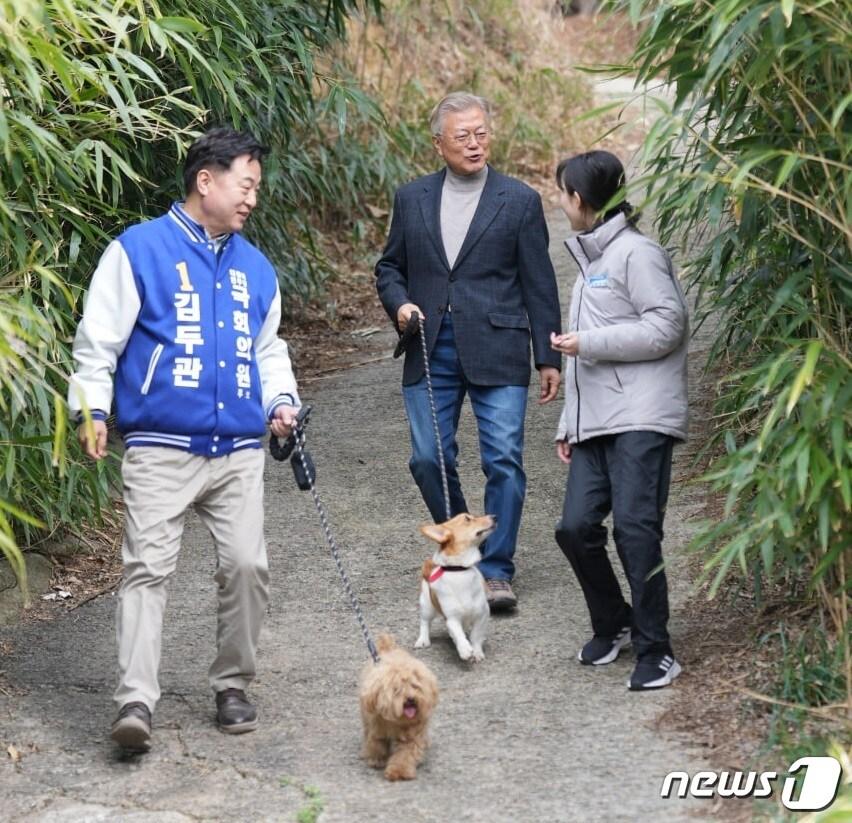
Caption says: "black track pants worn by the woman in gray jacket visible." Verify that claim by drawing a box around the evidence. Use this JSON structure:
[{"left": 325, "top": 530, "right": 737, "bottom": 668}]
[{"left": 556, "top": 431, "right": 674, "bottom": 657}]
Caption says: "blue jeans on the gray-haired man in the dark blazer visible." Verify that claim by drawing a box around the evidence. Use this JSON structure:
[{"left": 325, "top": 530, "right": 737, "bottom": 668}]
[{"left": 402, "top": 313, "right": 528, "bottom": 580}]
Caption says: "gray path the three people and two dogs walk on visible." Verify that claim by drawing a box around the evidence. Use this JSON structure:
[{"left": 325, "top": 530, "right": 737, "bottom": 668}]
[{"left": 0, "top": 214, "right": 712, "bottom": 823}]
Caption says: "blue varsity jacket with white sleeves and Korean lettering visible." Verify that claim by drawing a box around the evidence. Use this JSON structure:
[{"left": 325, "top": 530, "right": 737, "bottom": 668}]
[{"left": 68, "top": 203, "right": 299, "bottom": 457}]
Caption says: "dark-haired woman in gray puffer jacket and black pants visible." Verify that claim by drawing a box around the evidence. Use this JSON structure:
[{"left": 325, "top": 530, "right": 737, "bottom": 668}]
[{"left": 551, "top": 151, "right": 688, "bottom": 691}]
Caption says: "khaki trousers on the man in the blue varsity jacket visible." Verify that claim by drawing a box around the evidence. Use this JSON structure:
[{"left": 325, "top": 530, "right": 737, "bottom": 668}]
[{"left": 115, "top": 446, "right": 269, "bottom": 711}]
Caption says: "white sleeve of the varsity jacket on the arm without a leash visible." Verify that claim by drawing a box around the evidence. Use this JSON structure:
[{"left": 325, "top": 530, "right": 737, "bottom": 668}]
[{"left": 68, "top": 240, "right": 141, "bottom": 414}]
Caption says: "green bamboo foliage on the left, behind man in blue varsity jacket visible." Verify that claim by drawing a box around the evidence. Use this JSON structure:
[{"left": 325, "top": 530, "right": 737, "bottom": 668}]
[{"left": 0, "top": 0, "right": 387, "bottom": 584}]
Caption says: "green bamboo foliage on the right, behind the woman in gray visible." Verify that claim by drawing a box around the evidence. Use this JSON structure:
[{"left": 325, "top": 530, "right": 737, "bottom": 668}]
[{"left": 616, "top": 0, "right": 852, "bottom": 612}]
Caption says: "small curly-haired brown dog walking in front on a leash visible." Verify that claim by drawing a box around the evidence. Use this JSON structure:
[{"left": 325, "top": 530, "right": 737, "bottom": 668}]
[{"left": 360, "top": 634, "right": 438, "bottom": 780}]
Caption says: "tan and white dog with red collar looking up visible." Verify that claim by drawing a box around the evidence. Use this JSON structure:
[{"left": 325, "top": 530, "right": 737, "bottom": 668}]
[{"left": 414, "top": 514, "right": 497, "bottom": 661}]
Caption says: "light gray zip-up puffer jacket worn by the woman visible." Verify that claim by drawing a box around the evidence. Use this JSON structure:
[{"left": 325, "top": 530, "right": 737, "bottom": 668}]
[{"left": 556, "top": 214, "right": 689, "bottom": 443}]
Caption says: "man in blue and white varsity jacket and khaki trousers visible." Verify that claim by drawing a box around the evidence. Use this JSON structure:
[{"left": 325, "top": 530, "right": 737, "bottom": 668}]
[{"left": 69, "top": 128, "right": 299, "bottom": 752}]
